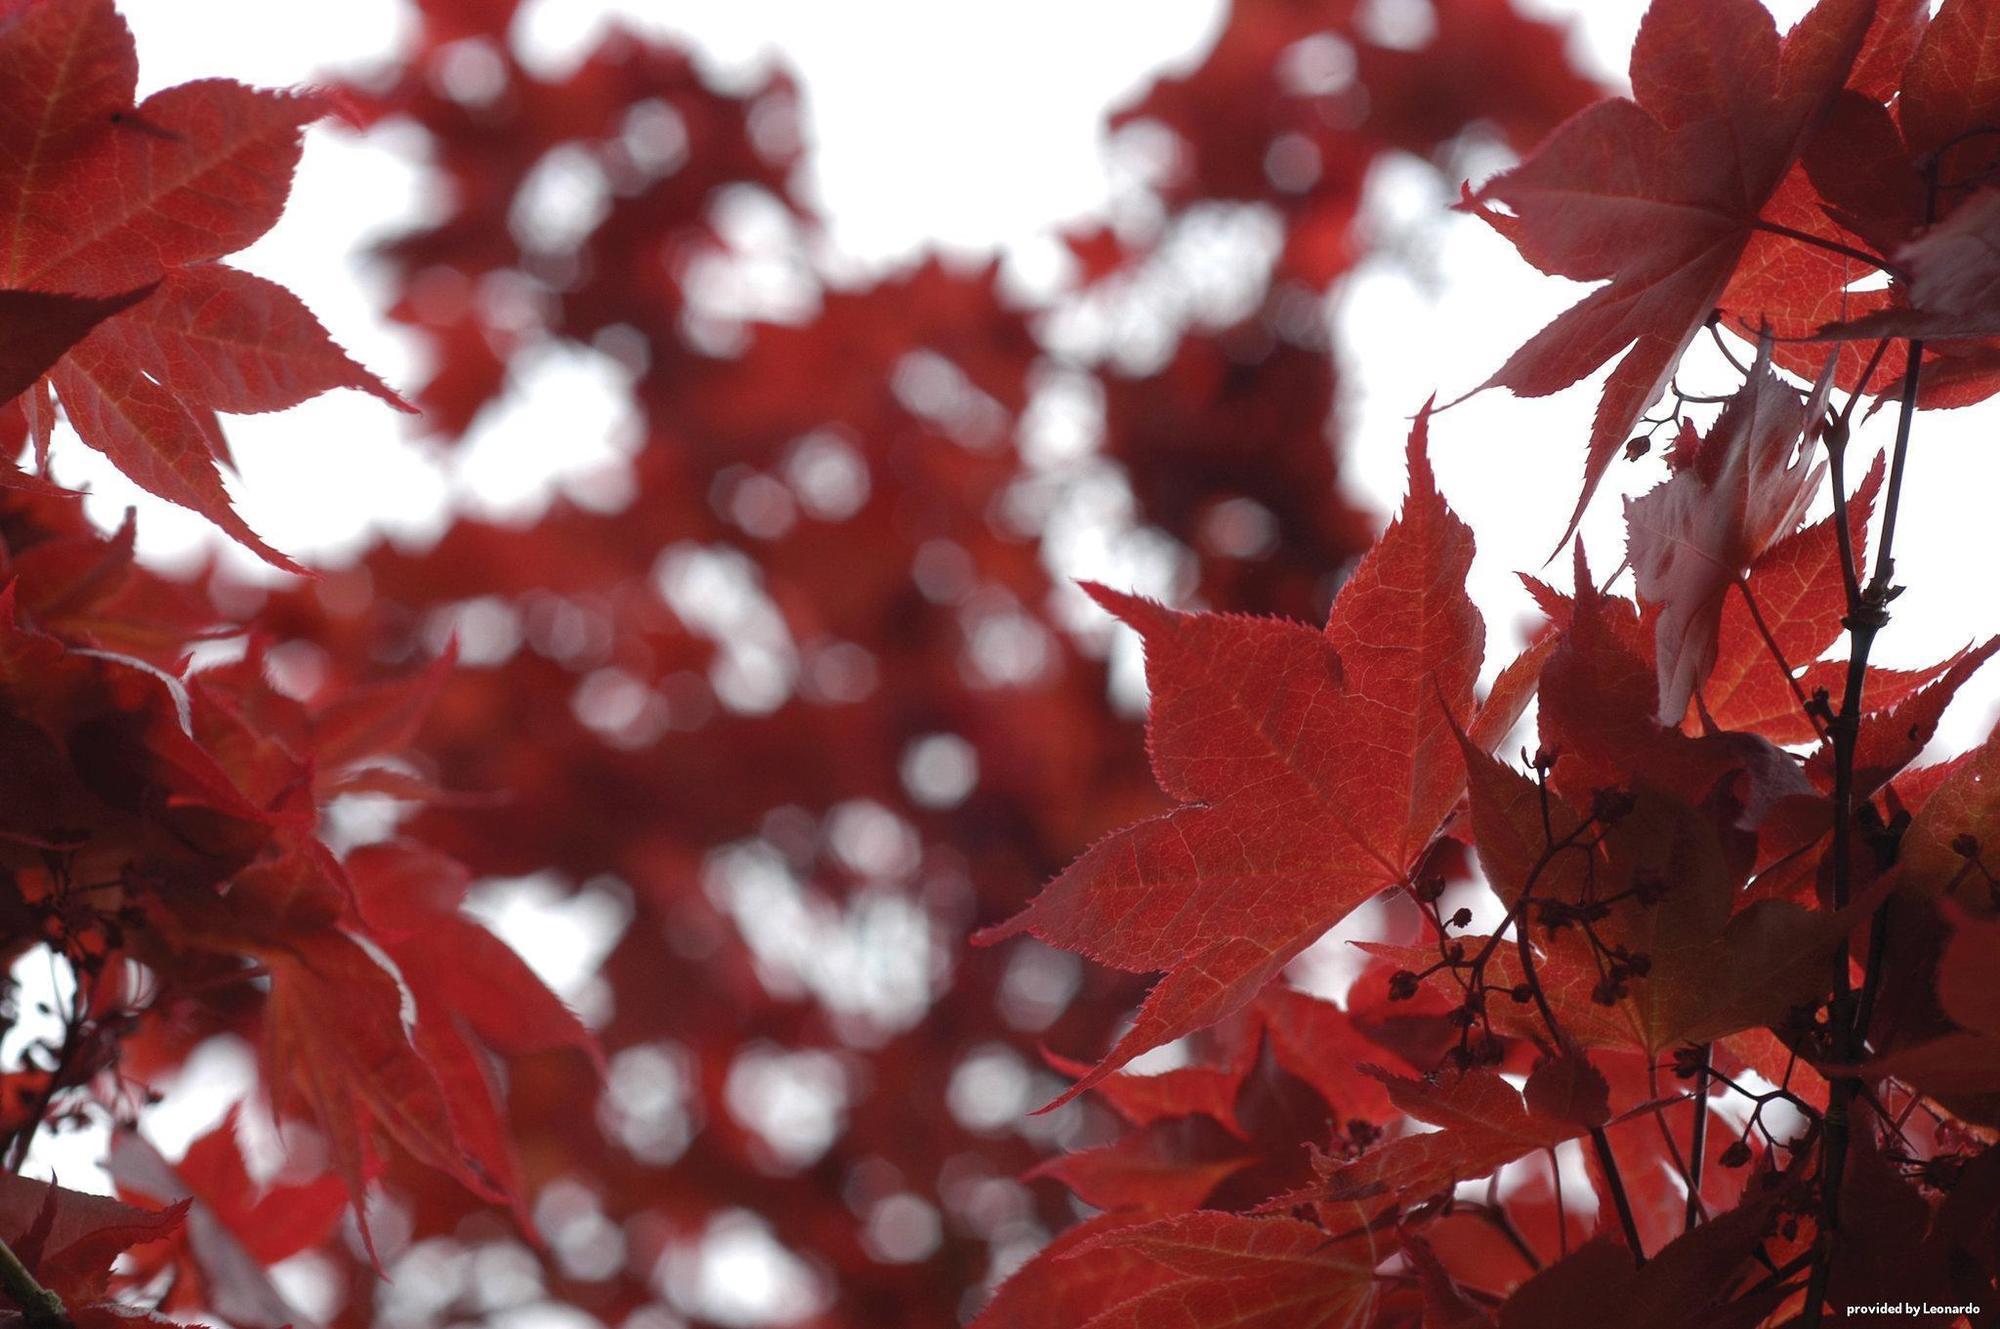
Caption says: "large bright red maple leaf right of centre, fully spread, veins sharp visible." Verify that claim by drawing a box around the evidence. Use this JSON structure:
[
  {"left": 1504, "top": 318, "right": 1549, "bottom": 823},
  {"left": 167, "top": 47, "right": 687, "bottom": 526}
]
[{"left": 980, "top": 416, "right": 1510, "bottom": 1101}]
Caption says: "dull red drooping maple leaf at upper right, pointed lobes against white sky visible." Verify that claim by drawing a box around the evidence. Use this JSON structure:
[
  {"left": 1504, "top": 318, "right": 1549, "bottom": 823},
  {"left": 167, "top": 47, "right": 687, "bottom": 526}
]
[{"left": 1466, "top": 0, "right": 1876, "bottom": 540}]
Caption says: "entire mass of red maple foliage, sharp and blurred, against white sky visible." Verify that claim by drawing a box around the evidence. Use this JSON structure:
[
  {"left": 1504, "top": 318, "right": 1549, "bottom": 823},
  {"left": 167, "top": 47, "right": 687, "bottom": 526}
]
[{"left": 11, "top": 0, "right": 2000, "bottom": 1329}]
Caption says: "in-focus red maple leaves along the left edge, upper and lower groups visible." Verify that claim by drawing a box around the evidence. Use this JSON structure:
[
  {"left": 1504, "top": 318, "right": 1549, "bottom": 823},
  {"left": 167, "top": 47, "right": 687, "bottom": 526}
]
[{"left": 0, "top": 0, "right": 596, "bottom": 1329}]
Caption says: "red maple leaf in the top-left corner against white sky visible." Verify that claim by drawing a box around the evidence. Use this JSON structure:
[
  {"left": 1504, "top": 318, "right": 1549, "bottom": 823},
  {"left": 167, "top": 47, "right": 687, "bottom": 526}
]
[{"left": 0, "top": 0, "right": 402, "bottom": 572}]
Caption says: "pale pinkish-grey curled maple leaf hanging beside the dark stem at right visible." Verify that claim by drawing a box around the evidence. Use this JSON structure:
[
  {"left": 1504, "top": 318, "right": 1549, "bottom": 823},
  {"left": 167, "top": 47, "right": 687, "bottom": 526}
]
[{"left": 1626, "top": 346, "right": 1832, "bottom": 725}]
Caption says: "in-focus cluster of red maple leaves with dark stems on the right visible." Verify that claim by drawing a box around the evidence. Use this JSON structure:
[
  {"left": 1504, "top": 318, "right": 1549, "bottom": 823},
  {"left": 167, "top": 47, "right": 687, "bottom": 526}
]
[{"left": 980, "top": 0, "right": 2000, "bottom": 1329}]
